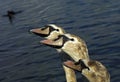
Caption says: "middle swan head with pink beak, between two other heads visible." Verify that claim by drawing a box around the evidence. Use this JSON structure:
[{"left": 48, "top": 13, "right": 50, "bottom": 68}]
[{"left": 41, "top": 34, "right": 89, "bottom": 61}]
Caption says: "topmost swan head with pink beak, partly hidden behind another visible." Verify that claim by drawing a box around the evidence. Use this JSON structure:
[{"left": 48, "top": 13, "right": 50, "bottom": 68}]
[{"left": 30, "top": 24, "right": 65, "bottom": 40}]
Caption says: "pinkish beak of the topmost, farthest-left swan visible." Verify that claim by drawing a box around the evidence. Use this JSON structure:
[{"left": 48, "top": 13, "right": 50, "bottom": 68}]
[{"left": 30, "top": 27, "right": 49, "bottom": 37}]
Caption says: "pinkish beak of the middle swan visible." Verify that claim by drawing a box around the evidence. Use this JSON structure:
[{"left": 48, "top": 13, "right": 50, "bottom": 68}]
[{"left": 40, "top": 37, "right": 63, "bottom": 48}]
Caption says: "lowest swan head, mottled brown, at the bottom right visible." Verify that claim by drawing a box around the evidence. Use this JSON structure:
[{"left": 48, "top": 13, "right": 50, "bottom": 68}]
[{"left": 64, "top": 59, "right": 110, "bottom": 82}]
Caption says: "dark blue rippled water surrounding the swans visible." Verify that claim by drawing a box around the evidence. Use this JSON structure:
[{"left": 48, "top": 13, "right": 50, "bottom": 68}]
[{"left": 0, "top": 0, "right": 120, "bottom": 82}]
